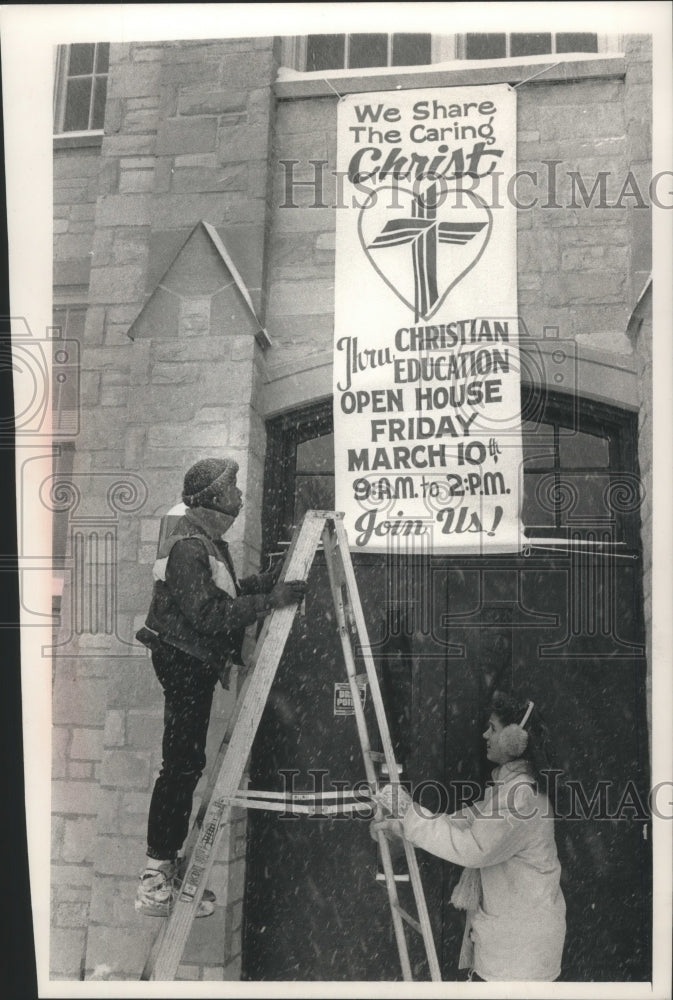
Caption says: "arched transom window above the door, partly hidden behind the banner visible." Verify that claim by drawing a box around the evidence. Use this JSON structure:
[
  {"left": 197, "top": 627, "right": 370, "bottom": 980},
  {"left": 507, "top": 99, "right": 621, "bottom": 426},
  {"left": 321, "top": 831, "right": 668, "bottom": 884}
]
[{"left": 263, "top": 386, "right": 639, "bottom": 552}]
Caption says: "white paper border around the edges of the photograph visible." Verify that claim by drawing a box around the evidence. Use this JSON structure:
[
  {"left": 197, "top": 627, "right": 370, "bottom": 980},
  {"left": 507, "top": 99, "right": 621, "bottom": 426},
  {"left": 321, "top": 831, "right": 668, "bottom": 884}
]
[{"left": 0, "top": 2, "right": 673, "bottom": 1000}]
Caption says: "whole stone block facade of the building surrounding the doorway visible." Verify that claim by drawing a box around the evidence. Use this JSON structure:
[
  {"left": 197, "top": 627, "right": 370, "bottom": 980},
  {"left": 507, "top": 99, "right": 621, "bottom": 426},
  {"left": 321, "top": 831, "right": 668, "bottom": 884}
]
[{"left": 51, "top": 36, "right": 652, "bottom": 980}]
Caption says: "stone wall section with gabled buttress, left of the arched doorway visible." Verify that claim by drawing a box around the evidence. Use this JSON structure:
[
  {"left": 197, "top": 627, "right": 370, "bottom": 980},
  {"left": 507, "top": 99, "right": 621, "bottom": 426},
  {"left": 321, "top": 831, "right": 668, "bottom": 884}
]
[{"left": 51, "top": 39, "right": 275, "bottom": 979}]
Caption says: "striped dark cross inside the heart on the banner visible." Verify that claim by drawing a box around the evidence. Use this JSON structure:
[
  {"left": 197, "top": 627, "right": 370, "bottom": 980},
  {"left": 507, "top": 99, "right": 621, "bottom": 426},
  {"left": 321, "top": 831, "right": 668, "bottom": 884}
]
[{"left": 368, "top": 184, "right": 486, "bottom": 321}]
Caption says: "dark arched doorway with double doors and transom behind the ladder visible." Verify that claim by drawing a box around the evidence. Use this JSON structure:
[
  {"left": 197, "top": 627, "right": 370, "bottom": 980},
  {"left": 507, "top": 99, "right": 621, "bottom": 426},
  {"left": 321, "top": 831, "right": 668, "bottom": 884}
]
[{"left": 244, "top": 394, "right": 651, "bottom": 981}]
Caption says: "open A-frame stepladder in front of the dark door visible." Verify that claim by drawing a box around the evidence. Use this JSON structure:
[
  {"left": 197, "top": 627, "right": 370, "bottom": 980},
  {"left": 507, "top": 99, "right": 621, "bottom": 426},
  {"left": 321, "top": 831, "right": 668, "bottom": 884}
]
[{"left": 141, "top": 510, "right": 441, "bottom": 982}]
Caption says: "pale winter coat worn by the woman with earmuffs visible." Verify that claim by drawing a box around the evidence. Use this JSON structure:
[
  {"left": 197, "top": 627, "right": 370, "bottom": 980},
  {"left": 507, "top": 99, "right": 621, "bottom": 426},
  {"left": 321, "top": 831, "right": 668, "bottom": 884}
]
[{"left": 404, "top": 760, "right": 566, "bottom": 982}]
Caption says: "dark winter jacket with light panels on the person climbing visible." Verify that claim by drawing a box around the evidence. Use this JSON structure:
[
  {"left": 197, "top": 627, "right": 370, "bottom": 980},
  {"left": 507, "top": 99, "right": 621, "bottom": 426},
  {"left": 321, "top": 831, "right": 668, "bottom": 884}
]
[{"left": 138, "top": 508, "right": 274, "bottom": 670}]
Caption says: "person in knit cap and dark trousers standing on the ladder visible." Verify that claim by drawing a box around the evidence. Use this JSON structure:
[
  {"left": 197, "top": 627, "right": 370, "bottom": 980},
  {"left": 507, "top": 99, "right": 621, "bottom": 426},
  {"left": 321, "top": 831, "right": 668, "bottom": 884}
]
[{"left": 135, "top": 458, "right": 306, "bottom": 916}]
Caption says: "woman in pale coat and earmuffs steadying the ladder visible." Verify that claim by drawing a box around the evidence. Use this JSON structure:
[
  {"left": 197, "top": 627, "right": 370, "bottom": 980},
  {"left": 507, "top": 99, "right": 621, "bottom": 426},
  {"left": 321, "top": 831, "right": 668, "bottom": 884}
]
[{"left": 372, "top": 692, "right": 566, "bottom": 982}]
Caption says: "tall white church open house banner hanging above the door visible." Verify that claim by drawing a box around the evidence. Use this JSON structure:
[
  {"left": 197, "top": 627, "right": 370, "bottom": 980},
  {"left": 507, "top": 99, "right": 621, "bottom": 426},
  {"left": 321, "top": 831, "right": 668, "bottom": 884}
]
[{"left": 334, "top": 85, "right": 522, "bottom": 553}]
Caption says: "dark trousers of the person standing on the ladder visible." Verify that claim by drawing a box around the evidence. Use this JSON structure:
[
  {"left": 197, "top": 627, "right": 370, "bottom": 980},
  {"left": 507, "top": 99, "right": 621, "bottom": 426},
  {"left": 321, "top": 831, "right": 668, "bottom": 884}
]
[{"left": 147, "top": 643, "right": 217, "bottom": 860}]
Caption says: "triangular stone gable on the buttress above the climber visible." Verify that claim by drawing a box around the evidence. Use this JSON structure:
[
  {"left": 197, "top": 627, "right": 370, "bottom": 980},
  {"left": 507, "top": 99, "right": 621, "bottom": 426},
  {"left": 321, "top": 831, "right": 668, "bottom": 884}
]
[{"left": 128, "top": 221, "right": 269, "bottom": 347}]
